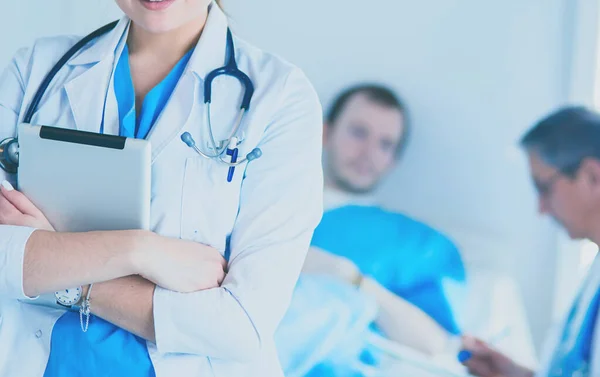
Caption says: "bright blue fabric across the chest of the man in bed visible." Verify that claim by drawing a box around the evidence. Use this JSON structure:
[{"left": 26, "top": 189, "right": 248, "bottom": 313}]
[{"left": 312, "top": 205, "right": 466, "bottom": 334}]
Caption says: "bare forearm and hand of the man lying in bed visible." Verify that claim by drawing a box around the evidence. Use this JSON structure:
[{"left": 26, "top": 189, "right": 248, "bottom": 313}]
[{"left": 302, "top": 247, "right": 449, "bottom": 355}]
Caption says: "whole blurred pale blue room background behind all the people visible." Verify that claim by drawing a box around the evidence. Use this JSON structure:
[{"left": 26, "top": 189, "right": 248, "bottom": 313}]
[{"left": 0, "top": 0, "right": 600, "bottom": 370}]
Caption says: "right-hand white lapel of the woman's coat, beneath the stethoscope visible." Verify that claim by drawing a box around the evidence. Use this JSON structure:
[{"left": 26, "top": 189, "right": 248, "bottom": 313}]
[{"left": 148, "top": 5, "right": 227, "bottom": 161}]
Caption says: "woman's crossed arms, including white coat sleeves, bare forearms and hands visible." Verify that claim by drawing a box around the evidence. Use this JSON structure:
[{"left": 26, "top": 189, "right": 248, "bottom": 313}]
[{"left": 0, "top": 54, "right": 323, "bottom": 362}]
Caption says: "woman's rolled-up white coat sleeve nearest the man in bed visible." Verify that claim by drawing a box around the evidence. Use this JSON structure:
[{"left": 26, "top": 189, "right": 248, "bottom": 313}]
[{"left": 154, "top": 70, "right": 323, "bottom": 362}]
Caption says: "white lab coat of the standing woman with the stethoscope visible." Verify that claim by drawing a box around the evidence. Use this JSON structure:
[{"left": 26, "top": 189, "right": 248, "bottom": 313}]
[{"left": 0, "top": 6, "right": 323, "bottom": 377}]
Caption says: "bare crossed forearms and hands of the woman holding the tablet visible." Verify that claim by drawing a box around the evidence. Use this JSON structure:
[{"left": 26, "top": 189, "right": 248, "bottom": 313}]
[{"left": 0, "top": 187, "right": 225, "bottom": 342}]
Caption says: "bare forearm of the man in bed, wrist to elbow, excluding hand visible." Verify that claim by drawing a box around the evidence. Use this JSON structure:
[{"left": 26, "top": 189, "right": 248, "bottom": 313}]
[{"left": 360, "top": 277, "right": 450, "bottom": 355}]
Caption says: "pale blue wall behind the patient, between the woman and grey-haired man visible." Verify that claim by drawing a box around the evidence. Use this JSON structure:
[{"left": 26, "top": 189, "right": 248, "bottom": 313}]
[{"left": 225, "top": 0, "right": 574, "bottom": 350}]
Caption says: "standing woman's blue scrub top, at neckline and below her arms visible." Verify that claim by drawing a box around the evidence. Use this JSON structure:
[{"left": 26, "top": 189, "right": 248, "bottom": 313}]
[{"left": 44, "top": 46, "right": 192, "bottom": 377}]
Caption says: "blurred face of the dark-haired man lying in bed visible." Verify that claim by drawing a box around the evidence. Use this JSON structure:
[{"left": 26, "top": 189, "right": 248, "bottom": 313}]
[{"left": 324, "top": 94, "right": 404, "bottom": 193}]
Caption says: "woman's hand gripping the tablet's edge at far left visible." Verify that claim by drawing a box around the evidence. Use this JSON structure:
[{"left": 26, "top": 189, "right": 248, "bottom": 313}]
[{"left": 0, "top": 181, "right": 54, "bottom": 231}]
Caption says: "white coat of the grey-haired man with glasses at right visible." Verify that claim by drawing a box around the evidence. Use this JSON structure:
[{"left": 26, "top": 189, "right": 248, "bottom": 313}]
[{"left": 535, "top": 257, "right": 600, "bottom": 377}]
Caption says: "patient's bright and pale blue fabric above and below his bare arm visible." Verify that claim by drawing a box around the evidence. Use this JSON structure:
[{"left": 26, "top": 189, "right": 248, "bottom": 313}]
[{"left": 275, "top": 206, "right": 466, "bottom": 377}]
